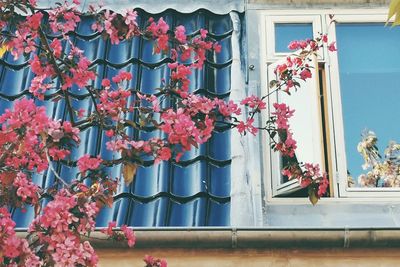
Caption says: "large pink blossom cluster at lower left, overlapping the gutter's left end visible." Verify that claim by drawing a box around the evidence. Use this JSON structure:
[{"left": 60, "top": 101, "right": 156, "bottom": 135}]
[{"left": 29, "top": 189, "right": 99, "bottom": 267}]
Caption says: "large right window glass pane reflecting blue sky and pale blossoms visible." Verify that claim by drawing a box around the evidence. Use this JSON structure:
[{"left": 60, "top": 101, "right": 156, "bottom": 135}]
[{"left": 336, "top": 23, "right": 400, "bottom": 187}]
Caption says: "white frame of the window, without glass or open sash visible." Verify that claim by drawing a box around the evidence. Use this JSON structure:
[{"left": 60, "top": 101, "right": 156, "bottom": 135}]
[{"left": 259, "top": 8, "right": 400, "bottom": 204}]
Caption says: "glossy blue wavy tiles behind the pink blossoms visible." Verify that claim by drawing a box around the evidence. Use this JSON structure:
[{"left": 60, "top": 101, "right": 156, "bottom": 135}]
[{"left": 0, "top": 10, "right": 238, "bottom": 227}]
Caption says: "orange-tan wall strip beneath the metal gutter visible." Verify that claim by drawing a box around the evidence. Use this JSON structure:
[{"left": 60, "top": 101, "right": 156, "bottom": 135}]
[{"left": 97, "top": 249, "right": 400, "bottom": 267}]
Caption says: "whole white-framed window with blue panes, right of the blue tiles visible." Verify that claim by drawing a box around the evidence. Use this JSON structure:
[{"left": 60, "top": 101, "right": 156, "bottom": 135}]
[{"left": 261, "top": 10, "right": 400, "bottom": 201}]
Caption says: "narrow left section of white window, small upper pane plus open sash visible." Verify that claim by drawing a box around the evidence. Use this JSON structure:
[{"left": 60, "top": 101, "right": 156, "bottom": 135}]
[{"left": 265, "top": 15, "right": 327, "bottom": 197}]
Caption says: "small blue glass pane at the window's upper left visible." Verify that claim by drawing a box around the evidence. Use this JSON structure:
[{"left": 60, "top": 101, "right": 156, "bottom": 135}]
[{"left": 275, "top": 23, "right": 313, "bottom": 52}]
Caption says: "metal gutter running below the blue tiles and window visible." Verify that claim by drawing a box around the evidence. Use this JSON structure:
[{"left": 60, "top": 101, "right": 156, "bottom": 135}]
[{"left": 79, "top": 228, "right": 400, "bottom": 249}]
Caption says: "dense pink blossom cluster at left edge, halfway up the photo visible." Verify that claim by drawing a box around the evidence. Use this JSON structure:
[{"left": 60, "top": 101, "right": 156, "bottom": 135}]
[{"left": 0, "top": 99, "right": 79, "bottom": 172}]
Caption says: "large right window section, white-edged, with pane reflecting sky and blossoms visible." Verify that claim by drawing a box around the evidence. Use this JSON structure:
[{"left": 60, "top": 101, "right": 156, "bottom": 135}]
[{"left": 332, "top": 15, "right": 400, "bottom": 197}]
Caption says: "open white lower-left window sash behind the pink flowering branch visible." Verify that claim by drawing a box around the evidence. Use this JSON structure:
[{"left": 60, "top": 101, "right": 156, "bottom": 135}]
[{"left": 268, "top": 57, "right": 325, "bottom": 196}]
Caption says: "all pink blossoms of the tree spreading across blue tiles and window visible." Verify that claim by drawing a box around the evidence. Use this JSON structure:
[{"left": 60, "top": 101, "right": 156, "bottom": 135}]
[{"left": 0, "top": 0, "right": 336, "bottom": 267}]
